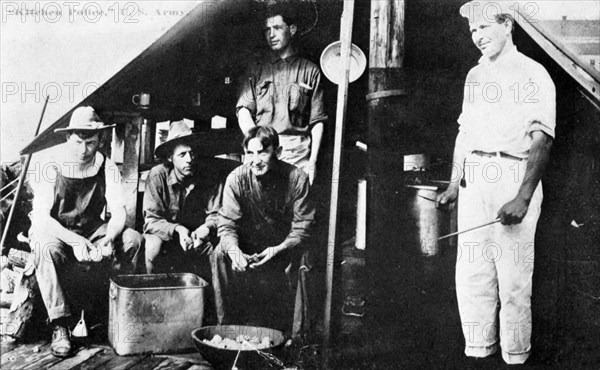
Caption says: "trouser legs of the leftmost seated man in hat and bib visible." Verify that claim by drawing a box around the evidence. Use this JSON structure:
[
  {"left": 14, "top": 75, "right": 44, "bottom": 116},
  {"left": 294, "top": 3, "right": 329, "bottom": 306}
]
[{"left": 29, "top": 224, "right": 142, "bottom": 320}]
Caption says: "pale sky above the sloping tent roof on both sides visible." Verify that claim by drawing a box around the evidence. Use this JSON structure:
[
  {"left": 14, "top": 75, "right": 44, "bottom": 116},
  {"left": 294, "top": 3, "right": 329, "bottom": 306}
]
[{"left": 0, "top": 0, "right": 600, "bottom": 162}]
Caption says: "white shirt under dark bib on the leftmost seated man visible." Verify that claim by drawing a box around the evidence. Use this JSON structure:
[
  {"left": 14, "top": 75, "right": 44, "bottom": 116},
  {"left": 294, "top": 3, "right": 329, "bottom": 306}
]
[{"left": 27, "top": 144, "right": 125, "bottom": 214}]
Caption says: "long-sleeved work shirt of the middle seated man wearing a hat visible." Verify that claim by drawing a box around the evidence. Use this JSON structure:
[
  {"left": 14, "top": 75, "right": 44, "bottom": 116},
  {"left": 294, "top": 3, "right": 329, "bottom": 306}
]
[{"left": 144, "top": 158, "right": 239, "bottom": 241}]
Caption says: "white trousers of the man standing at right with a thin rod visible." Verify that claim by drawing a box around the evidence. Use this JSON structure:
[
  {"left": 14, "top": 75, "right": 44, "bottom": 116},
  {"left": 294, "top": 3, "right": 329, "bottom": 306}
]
[{"left": 456, "top": 154, "right": 542, "bottom": 364}]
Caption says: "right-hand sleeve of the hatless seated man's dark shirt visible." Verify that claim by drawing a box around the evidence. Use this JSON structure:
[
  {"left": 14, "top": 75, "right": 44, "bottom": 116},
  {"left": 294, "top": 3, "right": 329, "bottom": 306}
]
[{"left": 283, "top": 173, "right": 315, "bottom": 249}]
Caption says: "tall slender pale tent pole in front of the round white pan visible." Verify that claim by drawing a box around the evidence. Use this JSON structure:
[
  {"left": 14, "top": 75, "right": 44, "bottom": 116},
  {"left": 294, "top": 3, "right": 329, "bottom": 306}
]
[{"left": 323, "top": 0, "right": 354, "bottom": 362}]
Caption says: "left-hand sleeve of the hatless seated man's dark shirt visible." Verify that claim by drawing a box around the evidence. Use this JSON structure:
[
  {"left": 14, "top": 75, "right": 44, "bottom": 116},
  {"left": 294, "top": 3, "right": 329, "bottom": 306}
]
[{"left": 218, "top": 172, "right": 242, "bottom": 252}]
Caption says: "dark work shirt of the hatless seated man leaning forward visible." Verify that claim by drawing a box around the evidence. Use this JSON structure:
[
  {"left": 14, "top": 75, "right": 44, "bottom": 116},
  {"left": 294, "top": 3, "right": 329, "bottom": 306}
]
[{"left": 219, "top": 161, "right": 315, "bottom": 253}]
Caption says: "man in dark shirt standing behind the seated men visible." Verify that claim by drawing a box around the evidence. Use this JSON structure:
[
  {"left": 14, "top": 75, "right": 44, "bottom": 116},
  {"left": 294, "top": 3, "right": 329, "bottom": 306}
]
[{"left": 236, "top": 6, "right": 327, "bottom": 184}]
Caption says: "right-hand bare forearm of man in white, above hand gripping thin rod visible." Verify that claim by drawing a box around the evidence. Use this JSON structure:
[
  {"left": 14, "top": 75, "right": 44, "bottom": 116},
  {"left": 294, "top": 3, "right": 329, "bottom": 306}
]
[{"left": 518, "top": 131, "right": 552, "bottom": 203}]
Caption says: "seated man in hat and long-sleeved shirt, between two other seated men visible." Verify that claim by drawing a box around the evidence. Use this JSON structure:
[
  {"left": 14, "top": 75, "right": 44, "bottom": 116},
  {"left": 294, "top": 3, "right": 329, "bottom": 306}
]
[{"left": 144, "top": 121, "right": 238, "bottom": 278}]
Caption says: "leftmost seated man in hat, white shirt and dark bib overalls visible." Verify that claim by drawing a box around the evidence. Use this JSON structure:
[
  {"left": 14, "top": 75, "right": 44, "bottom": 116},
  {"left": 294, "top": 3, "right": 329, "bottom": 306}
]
[{"left": 29, "top": 107, "right": 142, "bottom": 357}]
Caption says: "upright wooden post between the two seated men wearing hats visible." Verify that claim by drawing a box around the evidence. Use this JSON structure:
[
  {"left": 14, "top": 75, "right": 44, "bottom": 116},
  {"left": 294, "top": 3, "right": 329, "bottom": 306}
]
[{"left": 123, "top": 116, "right": 144, "bottom": 228}]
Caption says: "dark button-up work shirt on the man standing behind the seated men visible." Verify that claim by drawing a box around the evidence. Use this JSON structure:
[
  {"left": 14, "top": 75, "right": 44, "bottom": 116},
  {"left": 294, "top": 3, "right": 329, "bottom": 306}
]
[{"left": 236, "top": 54, "right": 327, "bottom": 135}]
